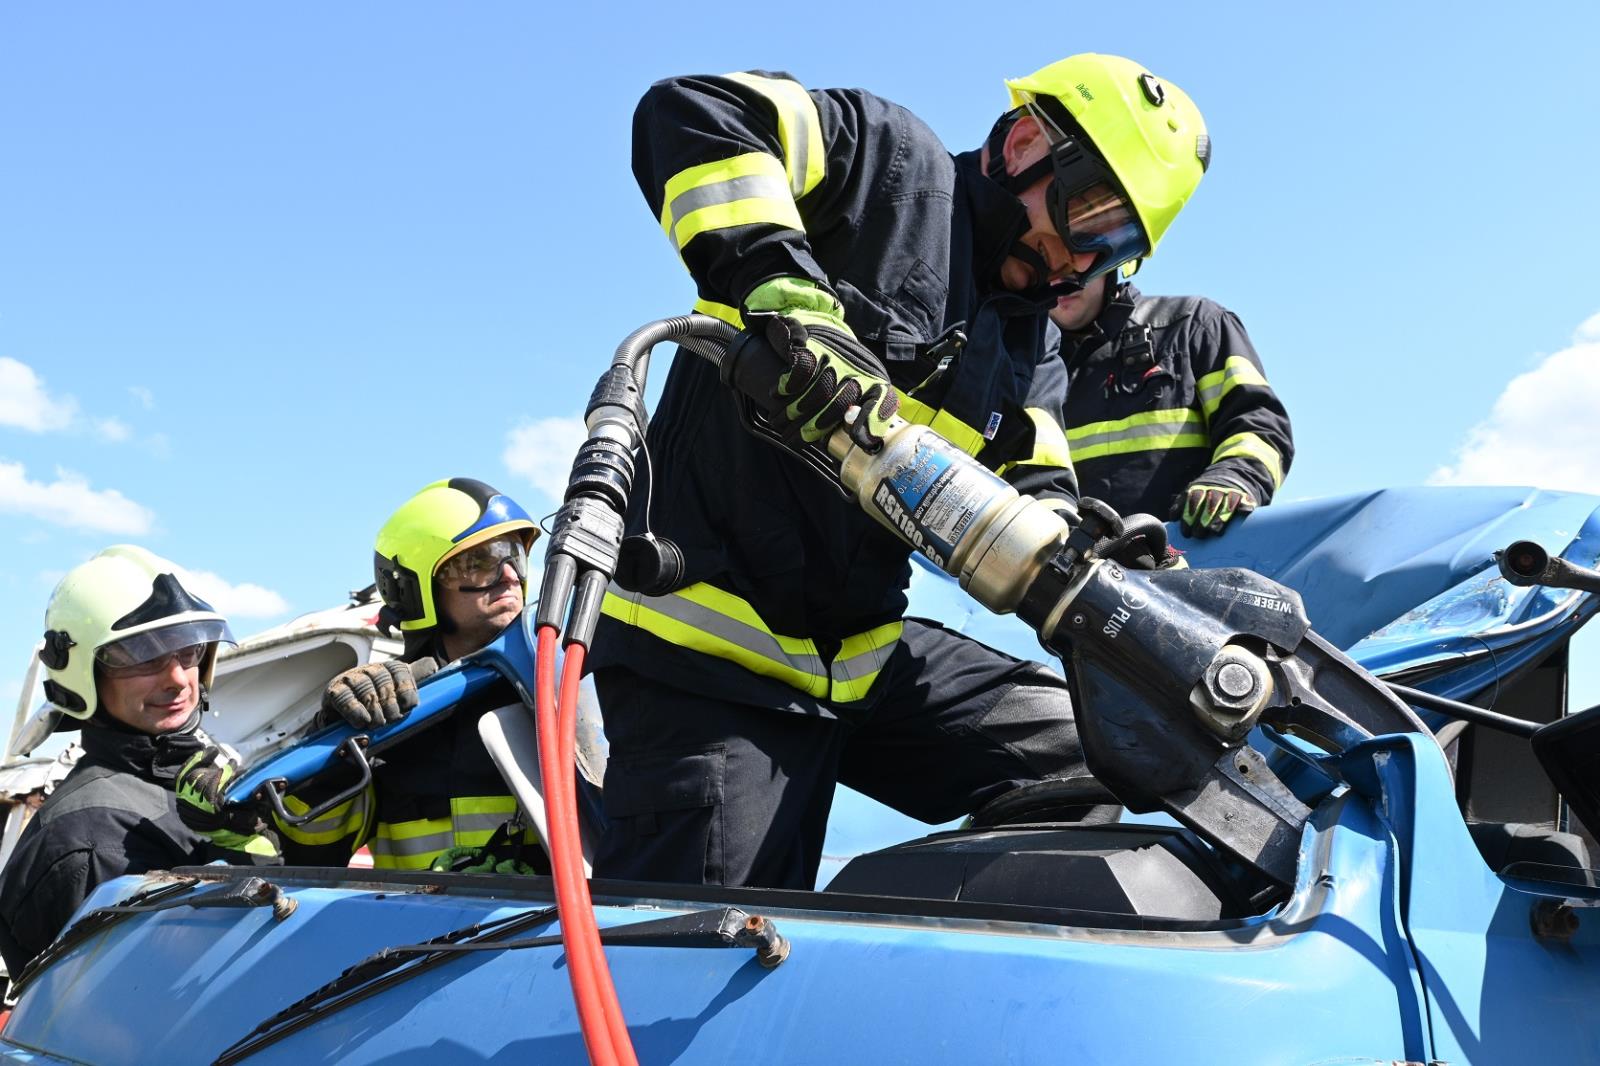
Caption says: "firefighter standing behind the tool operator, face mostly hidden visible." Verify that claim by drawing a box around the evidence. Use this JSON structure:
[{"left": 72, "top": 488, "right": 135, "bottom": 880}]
[{"left": 1050, "top": 274, "right": 1294, "bottom": 536}]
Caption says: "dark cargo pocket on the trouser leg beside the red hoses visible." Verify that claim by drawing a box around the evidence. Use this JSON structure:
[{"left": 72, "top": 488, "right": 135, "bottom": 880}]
[{"left": 605, "top": 744, "right": 726, "bottom": 885}]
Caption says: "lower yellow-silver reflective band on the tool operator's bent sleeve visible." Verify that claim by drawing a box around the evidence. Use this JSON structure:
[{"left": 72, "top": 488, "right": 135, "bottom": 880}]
[{"left": 661, "top": 152, "right": 805, "bottom": 251}]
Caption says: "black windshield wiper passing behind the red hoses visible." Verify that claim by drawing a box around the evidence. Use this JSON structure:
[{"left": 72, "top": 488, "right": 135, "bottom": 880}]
[{"left": 214, "top": 908, "right": 789, "bottom": 1066}]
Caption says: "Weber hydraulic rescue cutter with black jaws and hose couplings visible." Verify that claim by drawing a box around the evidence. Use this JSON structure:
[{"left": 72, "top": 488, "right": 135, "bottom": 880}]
[{"left": 539, "top": 315, "right": 1427, "bottom": 887}]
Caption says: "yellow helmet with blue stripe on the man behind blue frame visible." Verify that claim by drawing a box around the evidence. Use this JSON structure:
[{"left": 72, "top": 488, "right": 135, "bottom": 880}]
[{"left": 373, "top": 477, "right": 539, "bottom": 632}]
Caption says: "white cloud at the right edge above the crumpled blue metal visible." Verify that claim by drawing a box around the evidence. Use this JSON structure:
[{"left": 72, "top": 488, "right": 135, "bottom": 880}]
[{"left": 1427, "top": 314, "right": 1600, "bottom": 493}]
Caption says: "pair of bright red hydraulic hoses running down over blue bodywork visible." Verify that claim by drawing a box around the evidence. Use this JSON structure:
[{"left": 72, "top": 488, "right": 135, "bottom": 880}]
[{"left": 534, "top": 626, "right": 637, "bottom": 1066}]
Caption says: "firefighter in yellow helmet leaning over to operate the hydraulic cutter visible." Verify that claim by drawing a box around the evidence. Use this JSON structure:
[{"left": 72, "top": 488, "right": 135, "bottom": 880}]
[{"left": 589, "top": 54, "right": 1210, "bottom": 888}]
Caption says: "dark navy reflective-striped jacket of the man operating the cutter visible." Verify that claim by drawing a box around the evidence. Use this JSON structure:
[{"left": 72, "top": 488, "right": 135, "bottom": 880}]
[{"left": 590, "top": 74, "right": 1077, "bottom": 715}]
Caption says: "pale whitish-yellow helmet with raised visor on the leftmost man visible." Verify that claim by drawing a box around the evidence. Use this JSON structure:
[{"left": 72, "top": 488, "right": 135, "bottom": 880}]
[{"left": 38, "top": 544, "right": 235, "bottom": 719}]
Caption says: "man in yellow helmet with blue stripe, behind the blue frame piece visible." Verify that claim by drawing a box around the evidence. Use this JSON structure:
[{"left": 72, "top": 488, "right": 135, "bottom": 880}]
[{"left": 179, "top": 477, "right": 547, "bottom": 872}]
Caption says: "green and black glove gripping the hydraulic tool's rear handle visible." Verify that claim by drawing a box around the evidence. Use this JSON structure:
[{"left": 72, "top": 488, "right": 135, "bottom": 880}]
[{"left": 744, "top": 277, "right": 899, "bottom": 451}]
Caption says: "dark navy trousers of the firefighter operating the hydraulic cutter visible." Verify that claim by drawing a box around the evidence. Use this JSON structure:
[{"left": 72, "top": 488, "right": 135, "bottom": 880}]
[{"left": 595, "top": 619, "right": 1086, "bottom": 888}]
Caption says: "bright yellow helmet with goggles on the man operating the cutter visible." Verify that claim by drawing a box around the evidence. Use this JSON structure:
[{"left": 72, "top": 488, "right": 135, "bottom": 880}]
[{"left": 990, "top": 53, "right": 1211, "bottom": 282}]
